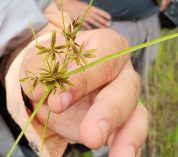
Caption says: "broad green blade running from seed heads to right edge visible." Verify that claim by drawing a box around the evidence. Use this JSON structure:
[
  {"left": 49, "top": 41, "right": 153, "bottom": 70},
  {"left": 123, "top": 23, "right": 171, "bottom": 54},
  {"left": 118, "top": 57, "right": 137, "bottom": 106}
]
[{"left": 66, "top": 33, "right": 178, "bottom": 76}]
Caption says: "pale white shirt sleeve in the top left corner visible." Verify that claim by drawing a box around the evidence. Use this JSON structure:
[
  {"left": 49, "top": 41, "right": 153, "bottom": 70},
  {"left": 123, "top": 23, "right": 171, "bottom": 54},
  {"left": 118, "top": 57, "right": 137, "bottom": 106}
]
[{"left": 0, "top": 0, "right": 52, "bottom": 57}]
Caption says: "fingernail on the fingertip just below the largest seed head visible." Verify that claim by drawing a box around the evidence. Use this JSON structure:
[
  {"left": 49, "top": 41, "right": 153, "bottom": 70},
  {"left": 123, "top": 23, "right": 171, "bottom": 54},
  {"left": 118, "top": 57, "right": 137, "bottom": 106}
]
[{"left": 61, "top": 92, "right": 72, "bottom": 111}]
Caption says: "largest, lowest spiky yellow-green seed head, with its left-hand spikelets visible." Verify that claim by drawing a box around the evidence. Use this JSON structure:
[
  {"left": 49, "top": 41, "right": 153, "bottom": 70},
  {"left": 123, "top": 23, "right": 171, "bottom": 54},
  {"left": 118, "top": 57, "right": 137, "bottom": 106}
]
[{"left": 20, "top": 62, "right": 74, "bottom": 94}]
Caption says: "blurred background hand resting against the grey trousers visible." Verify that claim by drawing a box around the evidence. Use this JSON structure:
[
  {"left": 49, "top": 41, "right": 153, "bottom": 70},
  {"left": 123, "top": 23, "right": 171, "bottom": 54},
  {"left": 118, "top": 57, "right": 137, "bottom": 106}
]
[{"left": 64, "top": 0, "right": 111, "bottom": 30}]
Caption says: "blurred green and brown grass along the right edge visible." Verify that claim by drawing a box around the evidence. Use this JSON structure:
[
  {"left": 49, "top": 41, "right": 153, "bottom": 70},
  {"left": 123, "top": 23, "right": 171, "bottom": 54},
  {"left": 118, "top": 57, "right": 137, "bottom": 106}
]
[{"left": 146, "top": 30, "right": 178, "bottom": 157}]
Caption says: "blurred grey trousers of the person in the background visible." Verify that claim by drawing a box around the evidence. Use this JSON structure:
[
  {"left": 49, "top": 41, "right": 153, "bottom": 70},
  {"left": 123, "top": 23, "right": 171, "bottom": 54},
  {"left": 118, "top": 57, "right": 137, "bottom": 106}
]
[{"left": 111, "top": 14, "right": 160, "bottom": 96}]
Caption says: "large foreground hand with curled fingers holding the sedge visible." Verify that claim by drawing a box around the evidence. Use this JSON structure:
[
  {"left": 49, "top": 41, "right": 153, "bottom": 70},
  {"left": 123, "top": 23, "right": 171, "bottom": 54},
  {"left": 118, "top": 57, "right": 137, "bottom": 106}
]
[{"left": 22, "top": 30, "right": 147, "bottom": 157}]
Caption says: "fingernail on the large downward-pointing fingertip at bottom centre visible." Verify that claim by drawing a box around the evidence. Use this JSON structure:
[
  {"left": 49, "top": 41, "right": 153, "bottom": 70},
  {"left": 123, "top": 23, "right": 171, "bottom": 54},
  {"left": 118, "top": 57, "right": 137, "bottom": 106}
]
[{"left": 98, "top": 120, "right": 109, "bottom": 145}]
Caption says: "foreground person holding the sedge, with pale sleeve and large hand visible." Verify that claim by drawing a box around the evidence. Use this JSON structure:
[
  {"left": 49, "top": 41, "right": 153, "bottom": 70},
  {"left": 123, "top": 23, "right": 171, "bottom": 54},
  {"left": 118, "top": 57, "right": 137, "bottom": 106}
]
[{"left": 0, "top": 0, "right": 148, "bottom": 157}]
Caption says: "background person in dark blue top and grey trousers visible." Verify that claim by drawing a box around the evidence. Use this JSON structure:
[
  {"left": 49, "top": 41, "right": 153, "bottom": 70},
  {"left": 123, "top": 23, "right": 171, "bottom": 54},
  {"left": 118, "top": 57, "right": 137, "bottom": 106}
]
[{"left": 61, "top": 0, "right": 170, "bottom": 96}]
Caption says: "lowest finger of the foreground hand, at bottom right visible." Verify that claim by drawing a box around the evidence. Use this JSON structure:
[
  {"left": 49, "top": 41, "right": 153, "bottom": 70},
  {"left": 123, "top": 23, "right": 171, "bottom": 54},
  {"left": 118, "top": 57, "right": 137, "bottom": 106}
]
[{"left": 109, "top": 105, "right": 148, "bottom": 157}]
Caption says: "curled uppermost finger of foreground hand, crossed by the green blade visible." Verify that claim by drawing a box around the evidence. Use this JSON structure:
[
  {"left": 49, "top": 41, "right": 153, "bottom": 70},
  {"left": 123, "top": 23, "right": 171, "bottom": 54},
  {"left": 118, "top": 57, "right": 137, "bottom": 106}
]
[{"left": 48, "top": 30, "right": 128, "bottom": 113}]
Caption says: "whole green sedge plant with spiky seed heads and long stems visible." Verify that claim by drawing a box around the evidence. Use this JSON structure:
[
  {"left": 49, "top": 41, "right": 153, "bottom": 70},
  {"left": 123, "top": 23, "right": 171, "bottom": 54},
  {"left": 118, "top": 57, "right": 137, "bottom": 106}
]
[{"left": 7, "top": 0, "right": 178, "bottom": 157}]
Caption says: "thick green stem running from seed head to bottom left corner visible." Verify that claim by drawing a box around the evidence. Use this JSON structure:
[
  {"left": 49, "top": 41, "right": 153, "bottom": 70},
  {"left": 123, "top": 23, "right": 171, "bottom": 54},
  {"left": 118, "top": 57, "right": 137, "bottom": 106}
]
[{"left": 7, "top": 89, "right": 51, "bottom": 157}]
